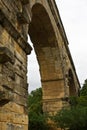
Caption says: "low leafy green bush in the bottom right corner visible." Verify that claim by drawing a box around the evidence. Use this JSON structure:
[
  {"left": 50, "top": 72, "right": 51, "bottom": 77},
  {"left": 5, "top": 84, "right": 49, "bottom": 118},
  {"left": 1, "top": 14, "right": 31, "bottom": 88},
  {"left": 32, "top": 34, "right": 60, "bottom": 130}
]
[{"left": 53, "top": 107, "right": 87, "bottom": 130}]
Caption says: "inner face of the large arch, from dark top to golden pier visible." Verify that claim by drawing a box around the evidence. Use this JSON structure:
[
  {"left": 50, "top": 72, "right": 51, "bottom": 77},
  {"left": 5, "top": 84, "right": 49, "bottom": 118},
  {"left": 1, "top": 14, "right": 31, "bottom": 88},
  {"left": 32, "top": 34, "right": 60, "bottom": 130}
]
[{"left": 29, "top": 3, "right": 64, "bottom": 112}]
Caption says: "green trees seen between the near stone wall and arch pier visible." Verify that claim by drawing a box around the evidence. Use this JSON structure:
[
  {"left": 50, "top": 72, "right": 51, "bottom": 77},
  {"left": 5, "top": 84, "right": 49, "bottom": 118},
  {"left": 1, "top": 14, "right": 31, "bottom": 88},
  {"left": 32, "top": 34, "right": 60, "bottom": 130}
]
[{"left": 28, "top": 88, "right": 49, "bottom": 130}]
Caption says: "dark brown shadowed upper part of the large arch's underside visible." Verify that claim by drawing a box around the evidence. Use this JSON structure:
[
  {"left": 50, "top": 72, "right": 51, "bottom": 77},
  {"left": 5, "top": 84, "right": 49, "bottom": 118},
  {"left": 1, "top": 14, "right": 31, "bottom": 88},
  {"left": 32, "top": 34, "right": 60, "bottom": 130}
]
[{"left": 29, "top": 3, "right": 55, "bottom": 47}]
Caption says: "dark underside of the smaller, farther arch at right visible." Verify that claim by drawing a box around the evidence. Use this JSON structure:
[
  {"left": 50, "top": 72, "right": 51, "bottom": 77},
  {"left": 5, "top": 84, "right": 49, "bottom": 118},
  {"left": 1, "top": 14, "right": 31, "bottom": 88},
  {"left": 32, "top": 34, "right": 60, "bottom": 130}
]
[{"left": 68, "top": 69, "right": 77, "bottom": 96}]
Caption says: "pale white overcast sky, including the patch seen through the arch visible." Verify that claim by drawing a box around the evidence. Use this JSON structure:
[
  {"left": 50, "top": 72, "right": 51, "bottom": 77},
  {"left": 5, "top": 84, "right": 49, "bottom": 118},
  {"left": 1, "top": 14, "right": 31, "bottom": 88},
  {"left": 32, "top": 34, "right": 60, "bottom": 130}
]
[{"left": 28, "top": 0, "right": 87, "bottom": 91}]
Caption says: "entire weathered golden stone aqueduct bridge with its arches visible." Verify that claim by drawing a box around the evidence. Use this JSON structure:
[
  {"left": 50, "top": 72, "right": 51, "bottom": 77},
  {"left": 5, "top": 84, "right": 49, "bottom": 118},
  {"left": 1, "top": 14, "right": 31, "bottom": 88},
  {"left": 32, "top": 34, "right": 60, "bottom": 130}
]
[{"left": 0, "top": 0, "right": 80, "bottom": 130}]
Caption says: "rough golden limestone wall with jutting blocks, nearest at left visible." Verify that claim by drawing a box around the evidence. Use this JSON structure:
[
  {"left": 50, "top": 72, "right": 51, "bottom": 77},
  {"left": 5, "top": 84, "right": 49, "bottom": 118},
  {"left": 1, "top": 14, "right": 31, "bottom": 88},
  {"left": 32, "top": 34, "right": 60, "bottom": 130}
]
[{"left": 0, "top": 0, "right": 31, "bottom": 130}]
